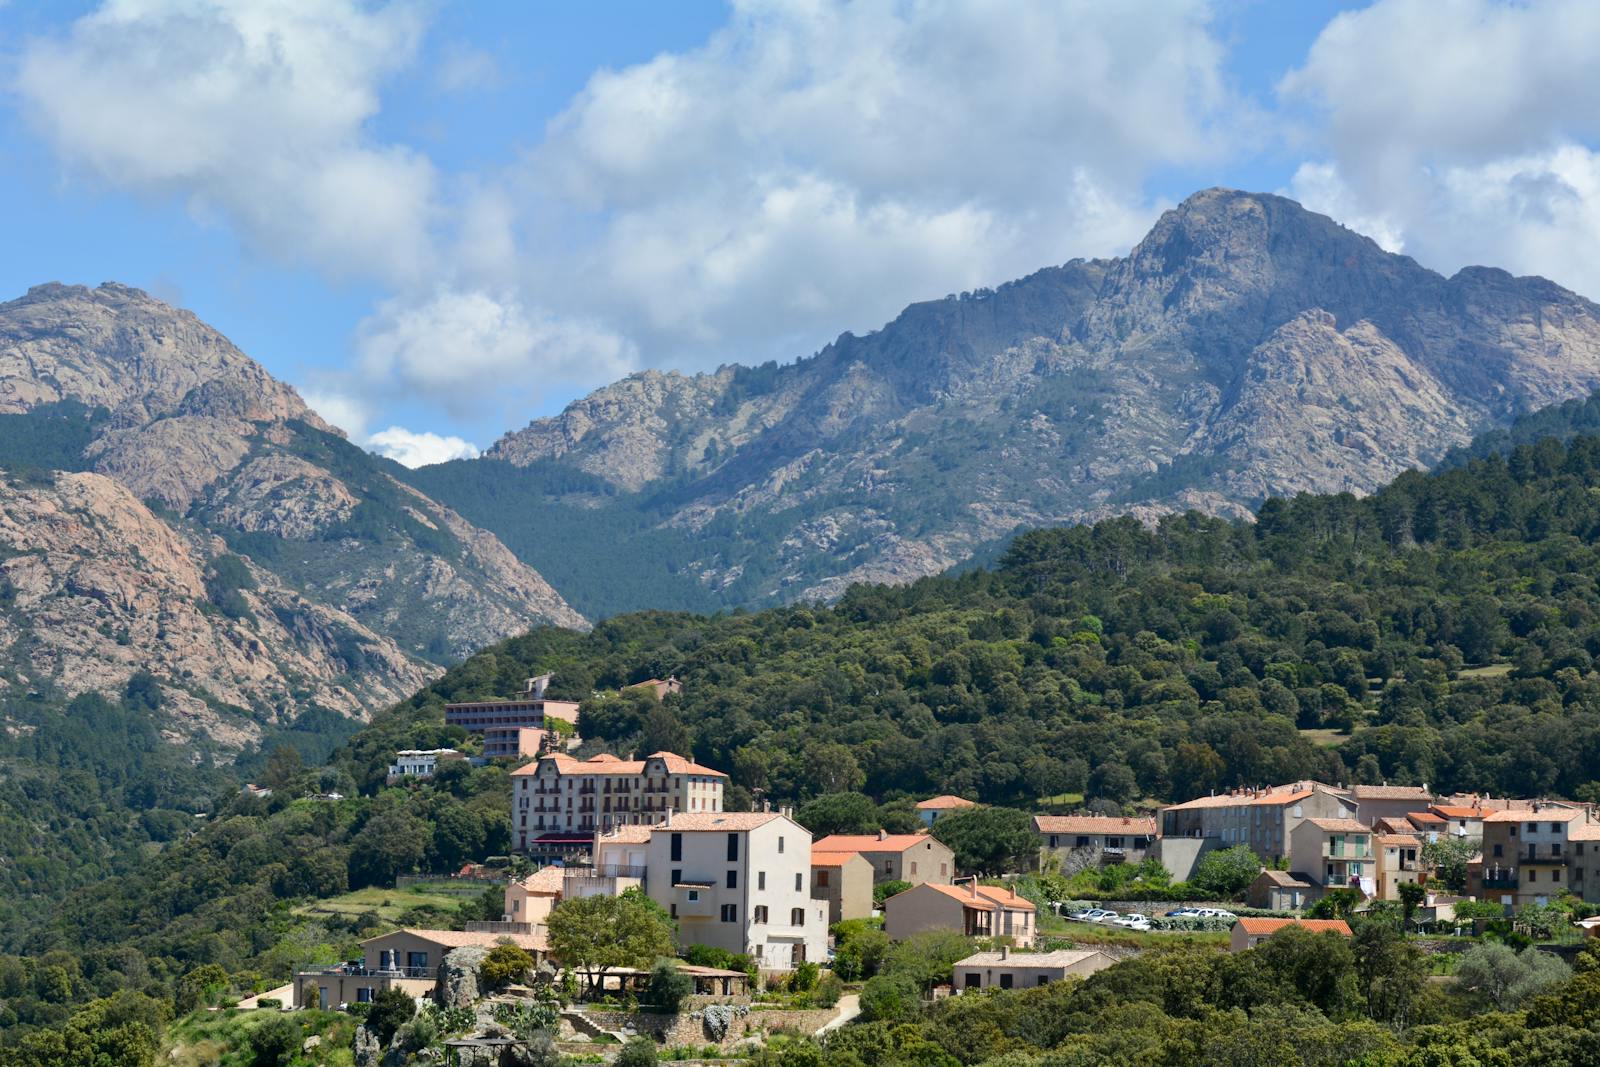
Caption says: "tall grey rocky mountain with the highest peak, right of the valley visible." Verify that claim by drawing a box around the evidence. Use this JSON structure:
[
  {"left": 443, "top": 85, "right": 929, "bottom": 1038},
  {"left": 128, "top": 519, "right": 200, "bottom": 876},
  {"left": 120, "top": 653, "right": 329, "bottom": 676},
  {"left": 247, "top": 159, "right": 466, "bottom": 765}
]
[{"left": 467, "top": 189, "right": 1600, "bottom": 606}]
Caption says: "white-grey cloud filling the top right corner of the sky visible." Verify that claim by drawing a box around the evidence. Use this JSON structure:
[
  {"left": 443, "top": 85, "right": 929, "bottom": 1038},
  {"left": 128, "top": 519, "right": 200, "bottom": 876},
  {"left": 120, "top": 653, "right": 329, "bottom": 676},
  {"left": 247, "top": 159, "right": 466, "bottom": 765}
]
[{"left": 1278, "top": 0, "right": 1600, "bottom": 296}]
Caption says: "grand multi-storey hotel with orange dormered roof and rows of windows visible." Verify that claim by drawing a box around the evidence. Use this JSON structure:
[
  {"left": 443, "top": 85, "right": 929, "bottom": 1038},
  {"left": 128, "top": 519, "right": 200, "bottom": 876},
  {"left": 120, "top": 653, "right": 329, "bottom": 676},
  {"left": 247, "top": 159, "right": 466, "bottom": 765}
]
[{"left": 510, "top": 752, "right": 728, "bottom": 856}]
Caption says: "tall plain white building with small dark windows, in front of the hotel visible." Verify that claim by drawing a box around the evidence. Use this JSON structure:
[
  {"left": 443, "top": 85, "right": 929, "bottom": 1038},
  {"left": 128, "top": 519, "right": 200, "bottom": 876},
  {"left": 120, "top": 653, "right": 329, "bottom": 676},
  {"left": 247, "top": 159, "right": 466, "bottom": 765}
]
[{"left": 645, "top": 811, "right": 829, "bottom": 971}]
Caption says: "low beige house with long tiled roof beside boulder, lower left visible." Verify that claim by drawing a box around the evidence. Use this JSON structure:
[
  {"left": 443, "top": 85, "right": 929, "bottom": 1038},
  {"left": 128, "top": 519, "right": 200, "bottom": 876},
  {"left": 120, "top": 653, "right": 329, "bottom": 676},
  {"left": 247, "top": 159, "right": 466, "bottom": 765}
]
[{"left": 294, "top": 929, "right": 550, "bottom": 1009}]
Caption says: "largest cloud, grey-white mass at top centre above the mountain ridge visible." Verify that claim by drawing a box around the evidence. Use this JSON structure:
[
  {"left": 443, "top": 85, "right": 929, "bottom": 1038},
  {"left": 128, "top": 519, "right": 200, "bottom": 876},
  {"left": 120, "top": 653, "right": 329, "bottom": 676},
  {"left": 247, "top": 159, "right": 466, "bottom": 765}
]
[{"left": 517, "top": 0, "right": 1250, "bottom": 365}]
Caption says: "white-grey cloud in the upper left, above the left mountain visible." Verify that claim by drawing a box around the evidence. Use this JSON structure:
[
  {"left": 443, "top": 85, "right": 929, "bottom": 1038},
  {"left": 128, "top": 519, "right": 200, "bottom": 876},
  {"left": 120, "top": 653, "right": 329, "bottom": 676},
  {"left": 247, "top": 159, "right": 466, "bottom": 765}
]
[{"left": 14, "top": 0, "right": 437, "bottom": 285}]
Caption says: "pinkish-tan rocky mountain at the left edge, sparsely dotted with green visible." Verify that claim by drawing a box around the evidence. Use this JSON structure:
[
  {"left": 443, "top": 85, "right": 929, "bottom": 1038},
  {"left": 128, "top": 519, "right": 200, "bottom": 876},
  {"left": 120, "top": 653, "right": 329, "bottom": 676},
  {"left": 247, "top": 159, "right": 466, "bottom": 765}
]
[{"left": 0, "top": 285, "right": 586, "bottom": 747}]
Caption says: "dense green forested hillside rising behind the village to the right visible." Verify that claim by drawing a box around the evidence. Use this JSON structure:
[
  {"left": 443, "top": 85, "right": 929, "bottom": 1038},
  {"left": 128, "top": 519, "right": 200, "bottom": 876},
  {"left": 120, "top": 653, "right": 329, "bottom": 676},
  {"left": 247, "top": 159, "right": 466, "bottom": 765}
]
[{"left": 377, "top": 437, "right": 1600, "bottom": 803}]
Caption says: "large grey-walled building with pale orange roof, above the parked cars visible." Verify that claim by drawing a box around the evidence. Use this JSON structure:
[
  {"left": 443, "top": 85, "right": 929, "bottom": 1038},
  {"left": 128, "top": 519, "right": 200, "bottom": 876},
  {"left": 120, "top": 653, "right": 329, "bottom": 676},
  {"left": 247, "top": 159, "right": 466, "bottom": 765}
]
[{"left": 1162, "top": 781, "right": 1355, "bottom": 878}]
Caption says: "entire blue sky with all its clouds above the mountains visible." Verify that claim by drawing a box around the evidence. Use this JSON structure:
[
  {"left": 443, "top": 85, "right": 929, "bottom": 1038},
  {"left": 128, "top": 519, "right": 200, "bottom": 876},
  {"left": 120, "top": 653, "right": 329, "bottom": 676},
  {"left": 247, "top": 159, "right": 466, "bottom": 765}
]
[{"left": 0, "top": 0, "right": 1600, "bottom": 462}]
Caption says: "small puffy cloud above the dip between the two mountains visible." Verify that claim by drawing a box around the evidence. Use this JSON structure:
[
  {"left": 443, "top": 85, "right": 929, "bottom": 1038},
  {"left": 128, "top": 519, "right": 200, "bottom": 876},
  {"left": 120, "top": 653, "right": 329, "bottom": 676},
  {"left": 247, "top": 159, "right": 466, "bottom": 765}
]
[{"left": 357, "top": 288, "right": 637, "bottom": 414}]
